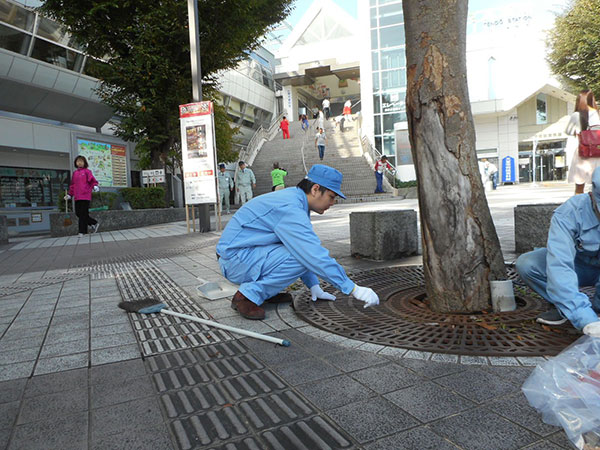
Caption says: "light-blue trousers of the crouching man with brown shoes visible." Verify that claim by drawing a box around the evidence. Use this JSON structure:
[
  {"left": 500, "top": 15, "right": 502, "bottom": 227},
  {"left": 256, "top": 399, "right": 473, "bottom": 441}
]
[{"left": 219, "top": 244, "right": 307, "bottom": 306}]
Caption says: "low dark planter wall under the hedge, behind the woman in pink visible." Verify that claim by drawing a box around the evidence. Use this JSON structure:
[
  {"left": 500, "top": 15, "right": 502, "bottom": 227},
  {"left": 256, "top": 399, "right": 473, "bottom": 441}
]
[{"left": 50, "top": 208, "right": 185, "bottom": 237}]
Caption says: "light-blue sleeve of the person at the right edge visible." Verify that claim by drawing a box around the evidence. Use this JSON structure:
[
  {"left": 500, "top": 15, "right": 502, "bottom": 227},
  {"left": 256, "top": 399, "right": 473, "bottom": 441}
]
[{"left": 546, "top": 209, "right": 598, "bottom": 329}]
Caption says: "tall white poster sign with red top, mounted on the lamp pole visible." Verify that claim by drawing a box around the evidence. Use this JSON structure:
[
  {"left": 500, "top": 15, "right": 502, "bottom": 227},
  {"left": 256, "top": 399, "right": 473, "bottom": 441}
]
[{"left": 179, "top": 102, "right": 217, "bottom": 205}]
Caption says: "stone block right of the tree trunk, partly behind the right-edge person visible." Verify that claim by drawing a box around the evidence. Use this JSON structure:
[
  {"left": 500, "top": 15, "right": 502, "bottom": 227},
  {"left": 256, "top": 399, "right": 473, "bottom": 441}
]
[{"left": 514, "top": 203, "right": 562, "bottom": 253}]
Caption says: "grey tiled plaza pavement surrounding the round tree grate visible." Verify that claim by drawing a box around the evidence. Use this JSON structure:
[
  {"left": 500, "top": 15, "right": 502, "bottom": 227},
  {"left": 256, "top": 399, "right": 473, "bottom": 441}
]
[{"left": 0, "top": 185, "right": 572, "bottom": 449}]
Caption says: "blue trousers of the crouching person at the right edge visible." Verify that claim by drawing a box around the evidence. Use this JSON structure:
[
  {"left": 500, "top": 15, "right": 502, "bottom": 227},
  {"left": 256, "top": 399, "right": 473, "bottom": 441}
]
[{"left": 515, "top": 248, "right": 600, "bottom": 313}]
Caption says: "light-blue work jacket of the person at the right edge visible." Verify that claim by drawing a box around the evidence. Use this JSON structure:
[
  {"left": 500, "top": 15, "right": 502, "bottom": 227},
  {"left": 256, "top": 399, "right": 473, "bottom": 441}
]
[{"left": 546, "top": 194, "right": 600, "bottom": 329}]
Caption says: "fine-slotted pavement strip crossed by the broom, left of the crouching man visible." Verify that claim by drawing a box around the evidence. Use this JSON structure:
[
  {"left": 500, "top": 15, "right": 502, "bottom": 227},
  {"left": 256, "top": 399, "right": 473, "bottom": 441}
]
[{"left": 112, "top": 261, "right": 233, "bottom": 356}]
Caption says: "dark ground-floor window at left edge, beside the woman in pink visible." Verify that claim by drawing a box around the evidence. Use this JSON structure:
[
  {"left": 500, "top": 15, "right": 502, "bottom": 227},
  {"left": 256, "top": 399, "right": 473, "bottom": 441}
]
[{"left": 0, "top": 167, "right": 69, "bottom": 208}]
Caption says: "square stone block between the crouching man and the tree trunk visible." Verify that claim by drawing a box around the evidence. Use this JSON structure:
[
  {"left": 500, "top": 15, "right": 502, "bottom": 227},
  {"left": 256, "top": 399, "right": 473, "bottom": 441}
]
[{"left": 350, "top": 209, "right": 419, "bottom": 261}]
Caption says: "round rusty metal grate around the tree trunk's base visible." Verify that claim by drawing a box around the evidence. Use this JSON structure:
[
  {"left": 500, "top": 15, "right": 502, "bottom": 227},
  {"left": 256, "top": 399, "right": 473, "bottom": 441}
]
[{"left": 294, "top": 266, "right": 579, "bottom": 356}]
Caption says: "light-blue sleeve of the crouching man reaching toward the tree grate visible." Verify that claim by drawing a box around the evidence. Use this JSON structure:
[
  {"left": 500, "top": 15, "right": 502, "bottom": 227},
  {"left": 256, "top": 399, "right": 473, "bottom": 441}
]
[{"left": 273, "top": 208, "right": 354, "bottom": 294}]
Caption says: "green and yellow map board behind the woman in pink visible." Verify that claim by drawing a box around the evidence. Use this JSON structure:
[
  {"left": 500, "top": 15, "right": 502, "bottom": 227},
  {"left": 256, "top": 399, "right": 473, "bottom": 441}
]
[{"left": 77, "top": 138, "right": 127, "bottom": 187}]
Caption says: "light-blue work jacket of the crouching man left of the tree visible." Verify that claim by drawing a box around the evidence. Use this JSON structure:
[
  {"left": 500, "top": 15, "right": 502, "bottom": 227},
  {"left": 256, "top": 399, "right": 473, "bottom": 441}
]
[{"left": 217, "top": 187, "right": 354, "bottom": 294}]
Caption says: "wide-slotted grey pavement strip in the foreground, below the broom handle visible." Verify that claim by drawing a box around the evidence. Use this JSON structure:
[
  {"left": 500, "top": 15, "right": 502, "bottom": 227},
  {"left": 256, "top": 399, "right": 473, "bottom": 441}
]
[{"left": 146, "top": 341, "right": 353, "bottom": 450}]
